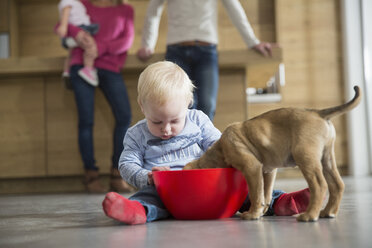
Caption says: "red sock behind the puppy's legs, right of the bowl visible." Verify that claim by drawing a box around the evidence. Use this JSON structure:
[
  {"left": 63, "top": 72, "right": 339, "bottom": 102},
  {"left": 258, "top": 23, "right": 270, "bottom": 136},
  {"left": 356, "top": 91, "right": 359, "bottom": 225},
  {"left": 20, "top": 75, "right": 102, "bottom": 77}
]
[{"left": 273, "top": 188, "right": 310, "bottom": 216}]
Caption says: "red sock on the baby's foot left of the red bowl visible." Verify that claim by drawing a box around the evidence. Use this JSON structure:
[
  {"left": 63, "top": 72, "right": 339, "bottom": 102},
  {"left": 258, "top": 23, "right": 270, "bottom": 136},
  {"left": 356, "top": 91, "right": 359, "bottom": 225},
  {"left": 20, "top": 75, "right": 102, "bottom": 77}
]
[{"left": 102, "top": 192, "right": 146, "bottom": 225}]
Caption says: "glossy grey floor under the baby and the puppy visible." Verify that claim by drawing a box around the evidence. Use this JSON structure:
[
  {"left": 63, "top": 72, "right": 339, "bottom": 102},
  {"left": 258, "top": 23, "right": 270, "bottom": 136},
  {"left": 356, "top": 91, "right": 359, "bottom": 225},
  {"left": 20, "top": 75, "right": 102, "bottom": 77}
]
[{"left": 0, "top": 177, "right": 372, "bottom": 248}]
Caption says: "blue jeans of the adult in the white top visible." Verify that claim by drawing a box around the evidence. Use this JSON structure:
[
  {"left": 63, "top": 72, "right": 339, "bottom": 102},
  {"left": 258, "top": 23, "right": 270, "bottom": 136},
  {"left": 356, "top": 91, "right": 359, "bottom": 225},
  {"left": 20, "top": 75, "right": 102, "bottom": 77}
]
[{"left": 165, "top": 44, "right": 219, "bottom": 120}]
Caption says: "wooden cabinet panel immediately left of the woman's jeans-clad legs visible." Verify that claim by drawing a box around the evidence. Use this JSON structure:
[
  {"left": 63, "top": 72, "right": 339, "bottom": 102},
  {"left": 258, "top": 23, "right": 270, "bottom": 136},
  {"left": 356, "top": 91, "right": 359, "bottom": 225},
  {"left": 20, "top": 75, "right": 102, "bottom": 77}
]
[{"left": 45, "top": 76, "right": 83, "bottom": 176}]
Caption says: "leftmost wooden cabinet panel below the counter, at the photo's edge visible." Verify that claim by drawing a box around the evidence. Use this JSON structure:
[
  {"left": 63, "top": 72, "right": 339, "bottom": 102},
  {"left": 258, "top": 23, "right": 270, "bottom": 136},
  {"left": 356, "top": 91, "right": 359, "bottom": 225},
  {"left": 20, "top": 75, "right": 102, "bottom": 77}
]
[{"left": 0, "top": 77, "right": 46, "bottom": 178}]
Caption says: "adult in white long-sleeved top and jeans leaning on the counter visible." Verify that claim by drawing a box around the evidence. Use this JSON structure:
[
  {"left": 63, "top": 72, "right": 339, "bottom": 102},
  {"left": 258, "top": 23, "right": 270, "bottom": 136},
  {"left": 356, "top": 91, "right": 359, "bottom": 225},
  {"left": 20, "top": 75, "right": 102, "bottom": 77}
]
[{"left": 137, "top": 0, "right": 271, "bottom": 120}]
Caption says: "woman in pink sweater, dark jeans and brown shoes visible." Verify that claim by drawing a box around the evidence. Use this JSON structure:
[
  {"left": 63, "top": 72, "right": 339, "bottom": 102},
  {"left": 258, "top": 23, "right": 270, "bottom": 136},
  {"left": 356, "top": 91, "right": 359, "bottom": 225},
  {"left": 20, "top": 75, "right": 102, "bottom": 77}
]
[{"left": 68, "top": 0, "right": 134, "bottom": 192}]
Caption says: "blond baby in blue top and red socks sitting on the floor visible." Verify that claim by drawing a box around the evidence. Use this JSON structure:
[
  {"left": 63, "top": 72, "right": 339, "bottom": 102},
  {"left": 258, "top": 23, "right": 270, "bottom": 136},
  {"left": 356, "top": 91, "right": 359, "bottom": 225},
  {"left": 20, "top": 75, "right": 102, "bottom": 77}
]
[{"left": 102, "top": 61, "right": 309, "bottom": 224}]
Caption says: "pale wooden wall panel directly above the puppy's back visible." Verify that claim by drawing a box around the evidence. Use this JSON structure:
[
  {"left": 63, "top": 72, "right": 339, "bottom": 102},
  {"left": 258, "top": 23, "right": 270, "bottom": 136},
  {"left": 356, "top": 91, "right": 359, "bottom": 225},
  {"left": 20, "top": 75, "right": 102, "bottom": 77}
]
[{"left": 276, "top": 0, "right": 343, "bottom": 104}]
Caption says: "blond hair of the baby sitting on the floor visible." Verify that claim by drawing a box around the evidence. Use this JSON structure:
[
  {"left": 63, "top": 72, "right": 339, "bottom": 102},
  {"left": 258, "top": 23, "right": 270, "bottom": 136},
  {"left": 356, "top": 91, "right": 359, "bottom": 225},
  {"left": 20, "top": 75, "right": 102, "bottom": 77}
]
[{"left": 137, "top": 61, "right": 195, "bottom": 106}]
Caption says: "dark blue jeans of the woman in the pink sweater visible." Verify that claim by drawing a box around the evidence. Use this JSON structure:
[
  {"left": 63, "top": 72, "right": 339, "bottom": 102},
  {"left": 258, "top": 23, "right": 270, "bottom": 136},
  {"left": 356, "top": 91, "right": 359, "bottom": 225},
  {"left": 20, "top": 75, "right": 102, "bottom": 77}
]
[{"left": 70, "top": 65, "right": 131, "bottom": 170}]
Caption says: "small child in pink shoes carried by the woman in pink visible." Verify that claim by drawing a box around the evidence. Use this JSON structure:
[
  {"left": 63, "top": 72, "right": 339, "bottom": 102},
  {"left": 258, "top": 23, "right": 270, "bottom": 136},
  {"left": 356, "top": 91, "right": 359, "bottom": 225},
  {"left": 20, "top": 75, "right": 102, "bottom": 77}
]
[{"left": 56, "top": 0, "right": 99, "bottom": 86}]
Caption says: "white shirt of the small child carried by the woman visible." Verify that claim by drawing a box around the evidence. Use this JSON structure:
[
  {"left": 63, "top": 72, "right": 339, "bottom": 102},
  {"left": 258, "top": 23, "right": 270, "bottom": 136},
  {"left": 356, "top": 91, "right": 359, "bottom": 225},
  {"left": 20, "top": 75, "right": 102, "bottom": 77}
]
[{"left": 58, "top": 0, "right": 90, "bottom": 26}]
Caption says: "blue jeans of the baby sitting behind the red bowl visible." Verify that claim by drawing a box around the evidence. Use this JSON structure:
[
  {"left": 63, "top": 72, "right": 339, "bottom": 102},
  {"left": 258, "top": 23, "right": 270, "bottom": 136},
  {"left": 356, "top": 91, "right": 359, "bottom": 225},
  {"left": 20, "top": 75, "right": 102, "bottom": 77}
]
[{"left": 129, "top": 186, "right": 285, "bottom": 222}]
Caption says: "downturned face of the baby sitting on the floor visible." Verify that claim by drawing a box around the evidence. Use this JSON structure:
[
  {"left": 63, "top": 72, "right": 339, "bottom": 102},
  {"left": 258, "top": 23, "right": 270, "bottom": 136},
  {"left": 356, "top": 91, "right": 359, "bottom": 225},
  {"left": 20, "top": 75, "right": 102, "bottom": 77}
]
[{"left": 142, "top": 99, "right": 188, "bottom": 140}]
